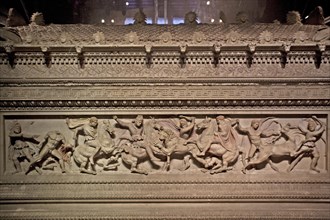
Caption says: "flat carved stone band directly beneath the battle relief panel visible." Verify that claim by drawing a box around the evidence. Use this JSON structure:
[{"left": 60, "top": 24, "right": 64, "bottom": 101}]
[{"left": 0, "top": 180, "right": 330, "bottom": 202}]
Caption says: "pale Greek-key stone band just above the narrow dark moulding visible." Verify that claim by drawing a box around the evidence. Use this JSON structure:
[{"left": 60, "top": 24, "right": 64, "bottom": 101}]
[{"left": 0, "top": 85, "right": 330, "bottom": 100}]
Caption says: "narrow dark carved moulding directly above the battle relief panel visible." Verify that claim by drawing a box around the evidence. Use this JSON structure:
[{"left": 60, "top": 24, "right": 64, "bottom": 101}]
[{"left": 0, "top": 100, "right": 330, "bottom": 111}]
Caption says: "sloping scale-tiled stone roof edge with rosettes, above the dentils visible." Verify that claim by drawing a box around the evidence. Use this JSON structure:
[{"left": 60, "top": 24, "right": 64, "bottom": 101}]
[{"left": 2, "top": 24, "right": 330, "bottom": 47}]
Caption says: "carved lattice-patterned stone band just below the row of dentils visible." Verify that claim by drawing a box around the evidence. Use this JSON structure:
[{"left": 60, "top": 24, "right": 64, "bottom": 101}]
[{"left": 0, "top": 61, "right": 330, "bottom": 78}]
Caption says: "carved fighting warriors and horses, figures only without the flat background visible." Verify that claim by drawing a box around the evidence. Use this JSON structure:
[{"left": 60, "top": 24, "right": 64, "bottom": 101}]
[{"left": 8, "top": 115, "right": 327, "bottom": 174}]
